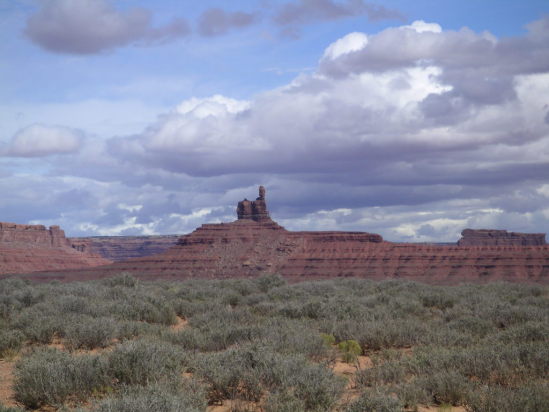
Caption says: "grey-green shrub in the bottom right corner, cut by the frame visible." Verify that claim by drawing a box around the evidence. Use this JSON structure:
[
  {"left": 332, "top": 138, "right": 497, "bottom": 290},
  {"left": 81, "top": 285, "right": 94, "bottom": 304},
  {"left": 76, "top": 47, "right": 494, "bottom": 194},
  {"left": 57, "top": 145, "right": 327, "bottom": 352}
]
[{"left": 467, "top": 384, "right": 549, "bottom": 412}]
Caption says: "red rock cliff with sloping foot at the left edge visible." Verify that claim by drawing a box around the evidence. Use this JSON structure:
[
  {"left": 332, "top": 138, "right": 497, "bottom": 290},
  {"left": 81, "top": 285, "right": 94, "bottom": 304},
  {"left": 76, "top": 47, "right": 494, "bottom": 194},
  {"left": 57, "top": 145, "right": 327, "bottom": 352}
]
[{"left": 0, "top": 222, "right": 111, "bottom": 274}]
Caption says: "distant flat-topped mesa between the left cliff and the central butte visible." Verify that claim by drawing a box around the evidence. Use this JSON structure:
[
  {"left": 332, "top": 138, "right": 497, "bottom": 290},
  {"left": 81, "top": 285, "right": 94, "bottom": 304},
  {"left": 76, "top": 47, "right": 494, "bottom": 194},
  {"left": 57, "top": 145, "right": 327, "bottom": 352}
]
[{"left": 69, "top": 235, "right": 180, "bottom": 262}]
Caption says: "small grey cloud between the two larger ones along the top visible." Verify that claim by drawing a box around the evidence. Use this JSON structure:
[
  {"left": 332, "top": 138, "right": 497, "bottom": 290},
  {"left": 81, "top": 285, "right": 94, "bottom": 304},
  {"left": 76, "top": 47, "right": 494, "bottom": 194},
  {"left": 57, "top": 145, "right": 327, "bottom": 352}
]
[{"left": 198, "top": 8, "right": 258, "bottom": 37}]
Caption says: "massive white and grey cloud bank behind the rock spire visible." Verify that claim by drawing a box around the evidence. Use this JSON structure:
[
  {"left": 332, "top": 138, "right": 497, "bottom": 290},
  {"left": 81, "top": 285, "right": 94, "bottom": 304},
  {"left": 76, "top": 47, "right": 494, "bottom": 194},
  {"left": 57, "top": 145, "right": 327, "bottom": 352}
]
[{"left": 6, "top": 17, "right": 549, "bottom": 241}]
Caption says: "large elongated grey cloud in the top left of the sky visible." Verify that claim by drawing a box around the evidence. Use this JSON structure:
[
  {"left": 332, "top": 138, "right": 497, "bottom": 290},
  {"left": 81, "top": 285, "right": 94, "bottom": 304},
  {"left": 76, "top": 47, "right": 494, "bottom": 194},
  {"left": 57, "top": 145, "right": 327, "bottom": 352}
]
[{"left": 25, "top": 0, "right": 190, "bottom": 54}]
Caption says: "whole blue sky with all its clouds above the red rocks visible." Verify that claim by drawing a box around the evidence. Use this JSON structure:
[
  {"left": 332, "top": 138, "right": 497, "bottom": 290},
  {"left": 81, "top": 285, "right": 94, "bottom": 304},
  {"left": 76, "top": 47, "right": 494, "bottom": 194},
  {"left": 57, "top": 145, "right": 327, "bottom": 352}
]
[{"left": 0, "top": 0, "right": 549, "bottom": 242}]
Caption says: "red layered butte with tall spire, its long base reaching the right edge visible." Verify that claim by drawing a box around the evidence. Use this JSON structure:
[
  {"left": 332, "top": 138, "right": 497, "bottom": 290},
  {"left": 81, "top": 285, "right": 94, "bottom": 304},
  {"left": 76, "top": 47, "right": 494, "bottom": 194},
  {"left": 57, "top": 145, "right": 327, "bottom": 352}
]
[{"left": 32, "top": 189, "right": 549, "bottom": 283}]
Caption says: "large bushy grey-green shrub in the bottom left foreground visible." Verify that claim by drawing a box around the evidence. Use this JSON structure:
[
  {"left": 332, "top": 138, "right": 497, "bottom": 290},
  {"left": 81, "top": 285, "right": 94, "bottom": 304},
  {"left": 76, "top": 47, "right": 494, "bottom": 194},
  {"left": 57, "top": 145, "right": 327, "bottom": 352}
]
[{"left": 14, "top": 348, "right": 109, "bottom": 408}]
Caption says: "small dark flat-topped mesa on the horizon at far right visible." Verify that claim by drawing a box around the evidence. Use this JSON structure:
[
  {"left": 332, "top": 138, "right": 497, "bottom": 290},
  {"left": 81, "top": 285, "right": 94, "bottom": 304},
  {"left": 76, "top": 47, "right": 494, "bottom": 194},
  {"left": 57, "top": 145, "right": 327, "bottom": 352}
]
[{"left": 458, "top": 229, "right": 546, "bottom": 246}]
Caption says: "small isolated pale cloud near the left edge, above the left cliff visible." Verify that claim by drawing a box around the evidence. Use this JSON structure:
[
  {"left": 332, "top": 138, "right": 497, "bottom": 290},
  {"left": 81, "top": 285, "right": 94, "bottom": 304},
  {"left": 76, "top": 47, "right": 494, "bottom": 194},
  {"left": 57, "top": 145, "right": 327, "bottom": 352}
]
[{"left": 5, "top": 124, "right": 83, "bottom": 157}]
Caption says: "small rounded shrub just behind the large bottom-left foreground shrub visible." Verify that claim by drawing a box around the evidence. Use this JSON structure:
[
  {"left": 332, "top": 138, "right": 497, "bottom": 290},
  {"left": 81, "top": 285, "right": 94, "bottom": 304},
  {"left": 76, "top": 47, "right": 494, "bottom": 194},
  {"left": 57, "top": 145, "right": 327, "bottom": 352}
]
[{"left": 64, "top": 316, "right": 116, "bottom": 349}]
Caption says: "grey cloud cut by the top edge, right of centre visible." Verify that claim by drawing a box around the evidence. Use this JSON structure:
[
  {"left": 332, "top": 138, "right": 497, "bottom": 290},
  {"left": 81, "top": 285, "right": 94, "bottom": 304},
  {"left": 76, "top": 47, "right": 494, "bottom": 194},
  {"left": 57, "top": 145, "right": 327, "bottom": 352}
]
[{"left": 274, "top": 0, "right": 403, "bottom": 26}]
